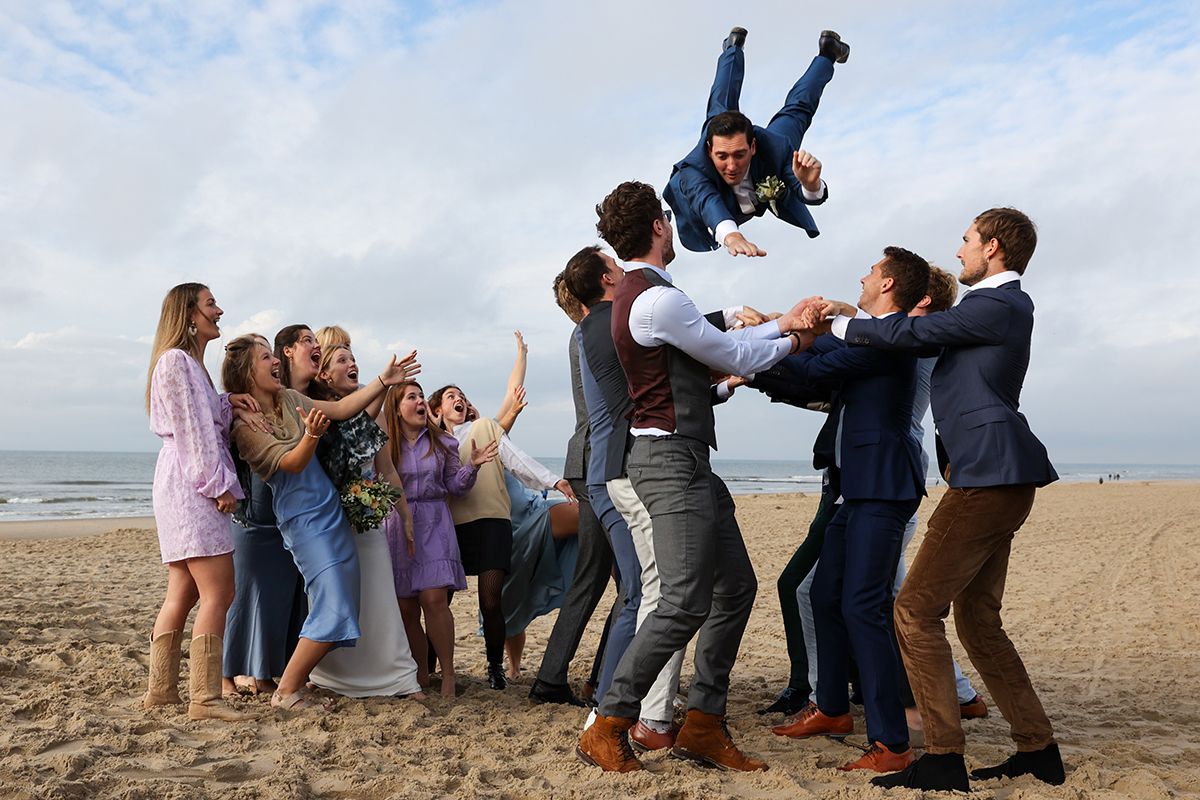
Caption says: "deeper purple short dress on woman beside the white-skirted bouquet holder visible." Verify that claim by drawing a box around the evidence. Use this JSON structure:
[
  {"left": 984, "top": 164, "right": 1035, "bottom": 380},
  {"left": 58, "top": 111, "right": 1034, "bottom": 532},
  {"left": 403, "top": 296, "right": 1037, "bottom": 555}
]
[{"left": 384, "top": 428, "right": 478, "bottom": 597}]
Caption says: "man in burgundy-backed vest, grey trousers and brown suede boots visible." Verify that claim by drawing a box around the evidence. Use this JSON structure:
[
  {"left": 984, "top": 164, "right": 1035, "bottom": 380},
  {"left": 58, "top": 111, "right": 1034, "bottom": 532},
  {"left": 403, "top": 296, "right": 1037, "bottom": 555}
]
[{"left": 577, "top": 181, "right": 803, "bottom": 772}]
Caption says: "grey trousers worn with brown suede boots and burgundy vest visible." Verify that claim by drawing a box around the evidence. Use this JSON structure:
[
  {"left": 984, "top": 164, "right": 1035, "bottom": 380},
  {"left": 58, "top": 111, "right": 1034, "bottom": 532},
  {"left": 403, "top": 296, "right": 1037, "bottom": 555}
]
[{"left": 600, "top": 435, "right": 758, "bottom": 718}]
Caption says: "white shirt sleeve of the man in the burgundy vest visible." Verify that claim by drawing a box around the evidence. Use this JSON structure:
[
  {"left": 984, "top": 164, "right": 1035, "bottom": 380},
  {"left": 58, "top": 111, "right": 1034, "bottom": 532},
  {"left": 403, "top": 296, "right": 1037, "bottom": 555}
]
[{"left": 629, "top": 287, "right": 792, "bottom": 375}]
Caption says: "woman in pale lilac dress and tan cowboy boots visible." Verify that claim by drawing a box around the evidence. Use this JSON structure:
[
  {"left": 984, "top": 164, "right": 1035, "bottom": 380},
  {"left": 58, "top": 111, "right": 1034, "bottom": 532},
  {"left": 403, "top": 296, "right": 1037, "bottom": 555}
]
[{"left": 142, "top": 283, "right": 257, "bottom": 721}]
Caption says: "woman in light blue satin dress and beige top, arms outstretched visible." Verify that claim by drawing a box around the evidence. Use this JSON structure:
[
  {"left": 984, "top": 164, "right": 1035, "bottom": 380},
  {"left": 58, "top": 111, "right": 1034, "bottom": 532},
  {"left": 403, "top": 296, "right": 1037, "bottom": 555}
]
[{"left": 221, "top": 335, "right": 415, "bottom": 709}]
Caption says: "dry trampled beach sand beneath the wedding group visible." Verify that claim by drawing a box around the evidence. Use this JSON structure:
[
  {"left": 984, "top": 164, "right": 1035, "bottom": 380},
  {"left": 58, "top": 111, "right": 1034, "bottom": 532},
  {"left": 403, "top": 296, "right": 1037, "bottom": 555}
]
[{"left": 0, "top": 483, "right": 1200, "bottom": 800}]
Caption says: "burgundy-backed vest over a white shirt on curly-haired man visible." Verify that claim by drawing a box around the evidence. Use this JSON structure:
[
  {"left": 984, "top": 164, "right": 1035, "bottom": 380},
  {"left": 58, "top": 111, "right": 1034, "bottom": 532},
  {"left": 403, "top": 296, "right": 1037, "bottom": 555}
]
[{"left": 612, "top": 269, "right": 716, "bottom": 450}]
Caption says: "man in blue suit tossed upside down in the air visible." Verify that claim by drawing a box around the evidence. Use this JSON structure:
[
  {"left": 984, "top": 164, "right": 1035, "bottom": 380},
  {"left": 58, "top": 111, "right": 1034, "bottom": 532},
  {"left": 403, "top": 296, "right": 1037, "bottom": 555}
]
[{"left": 662, "top": 28, "right": 850, "bottom": 255}]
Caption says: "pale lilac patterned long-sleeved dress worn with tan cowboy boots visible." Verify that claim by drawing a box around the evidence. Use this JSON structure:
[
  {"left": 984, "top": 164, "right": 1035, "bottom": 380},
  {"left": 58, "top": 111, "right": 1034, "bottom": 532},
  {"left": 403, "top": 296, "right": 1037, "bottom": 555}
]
[{"left": 150, "top": 350, "right": 242, "bottom": 564}]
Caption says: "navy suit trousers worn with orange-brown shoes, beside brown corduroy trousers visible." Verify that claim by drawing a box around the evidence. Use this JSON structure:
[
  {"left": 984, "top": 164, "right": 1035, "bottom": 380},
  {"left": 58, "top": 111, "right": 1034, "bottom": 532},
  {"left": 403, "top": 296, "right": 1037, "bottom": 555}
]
[{"left": 812, "top": 499, "right": 920, "bottom": 746}]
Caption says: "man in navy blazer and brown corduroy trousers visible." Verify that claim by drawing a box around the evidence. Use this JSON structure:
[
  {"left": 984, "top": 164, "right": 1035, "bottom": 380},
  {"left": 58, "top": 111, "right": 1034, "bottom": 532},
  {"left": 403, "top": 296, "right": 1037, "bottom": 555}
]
[{"left": 832, "top": 209, "right": 1064, "bottom": 792}]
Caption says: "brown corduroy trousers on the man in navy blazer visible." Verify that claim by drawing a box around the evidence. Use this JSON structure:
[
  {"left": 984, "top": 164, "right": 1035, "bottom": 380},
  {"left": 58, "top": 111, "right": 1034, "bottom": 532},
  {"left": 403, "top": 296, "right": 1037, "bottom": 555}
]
[{"left": 895, "top": 485, "right": 1054, "bottom": 753}]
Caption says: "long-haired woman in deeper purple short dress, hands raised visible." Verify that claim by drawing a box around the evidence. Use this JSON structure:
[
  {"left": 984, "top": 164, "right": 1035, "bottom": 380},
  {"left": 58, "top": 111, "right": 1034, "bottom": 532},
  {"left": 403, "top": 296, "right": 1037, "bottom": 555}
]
[{"left": 384, "top": 383, "right": 498, "bottom": 697}]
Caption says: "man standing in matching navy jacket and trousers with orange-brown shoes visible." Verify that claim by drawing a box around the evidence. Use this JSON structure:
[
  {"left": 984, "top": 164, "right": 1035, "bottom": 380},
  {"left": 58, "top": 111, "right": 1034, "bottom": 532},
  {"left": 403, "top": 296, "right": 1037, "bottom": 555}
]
[{"left": 774, "top": 247, "right": 929, "bottom": 772}]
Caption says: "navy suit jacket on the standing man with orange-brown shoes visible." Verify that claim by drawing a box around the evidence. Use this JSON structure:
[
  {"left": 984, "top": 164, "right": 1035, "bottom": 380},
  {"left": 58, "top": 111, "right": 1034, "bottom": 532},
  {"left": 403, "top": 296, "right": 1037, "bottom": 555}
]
[{"left": 780, "top": 335, "right": 925, "bottom": 500}]
